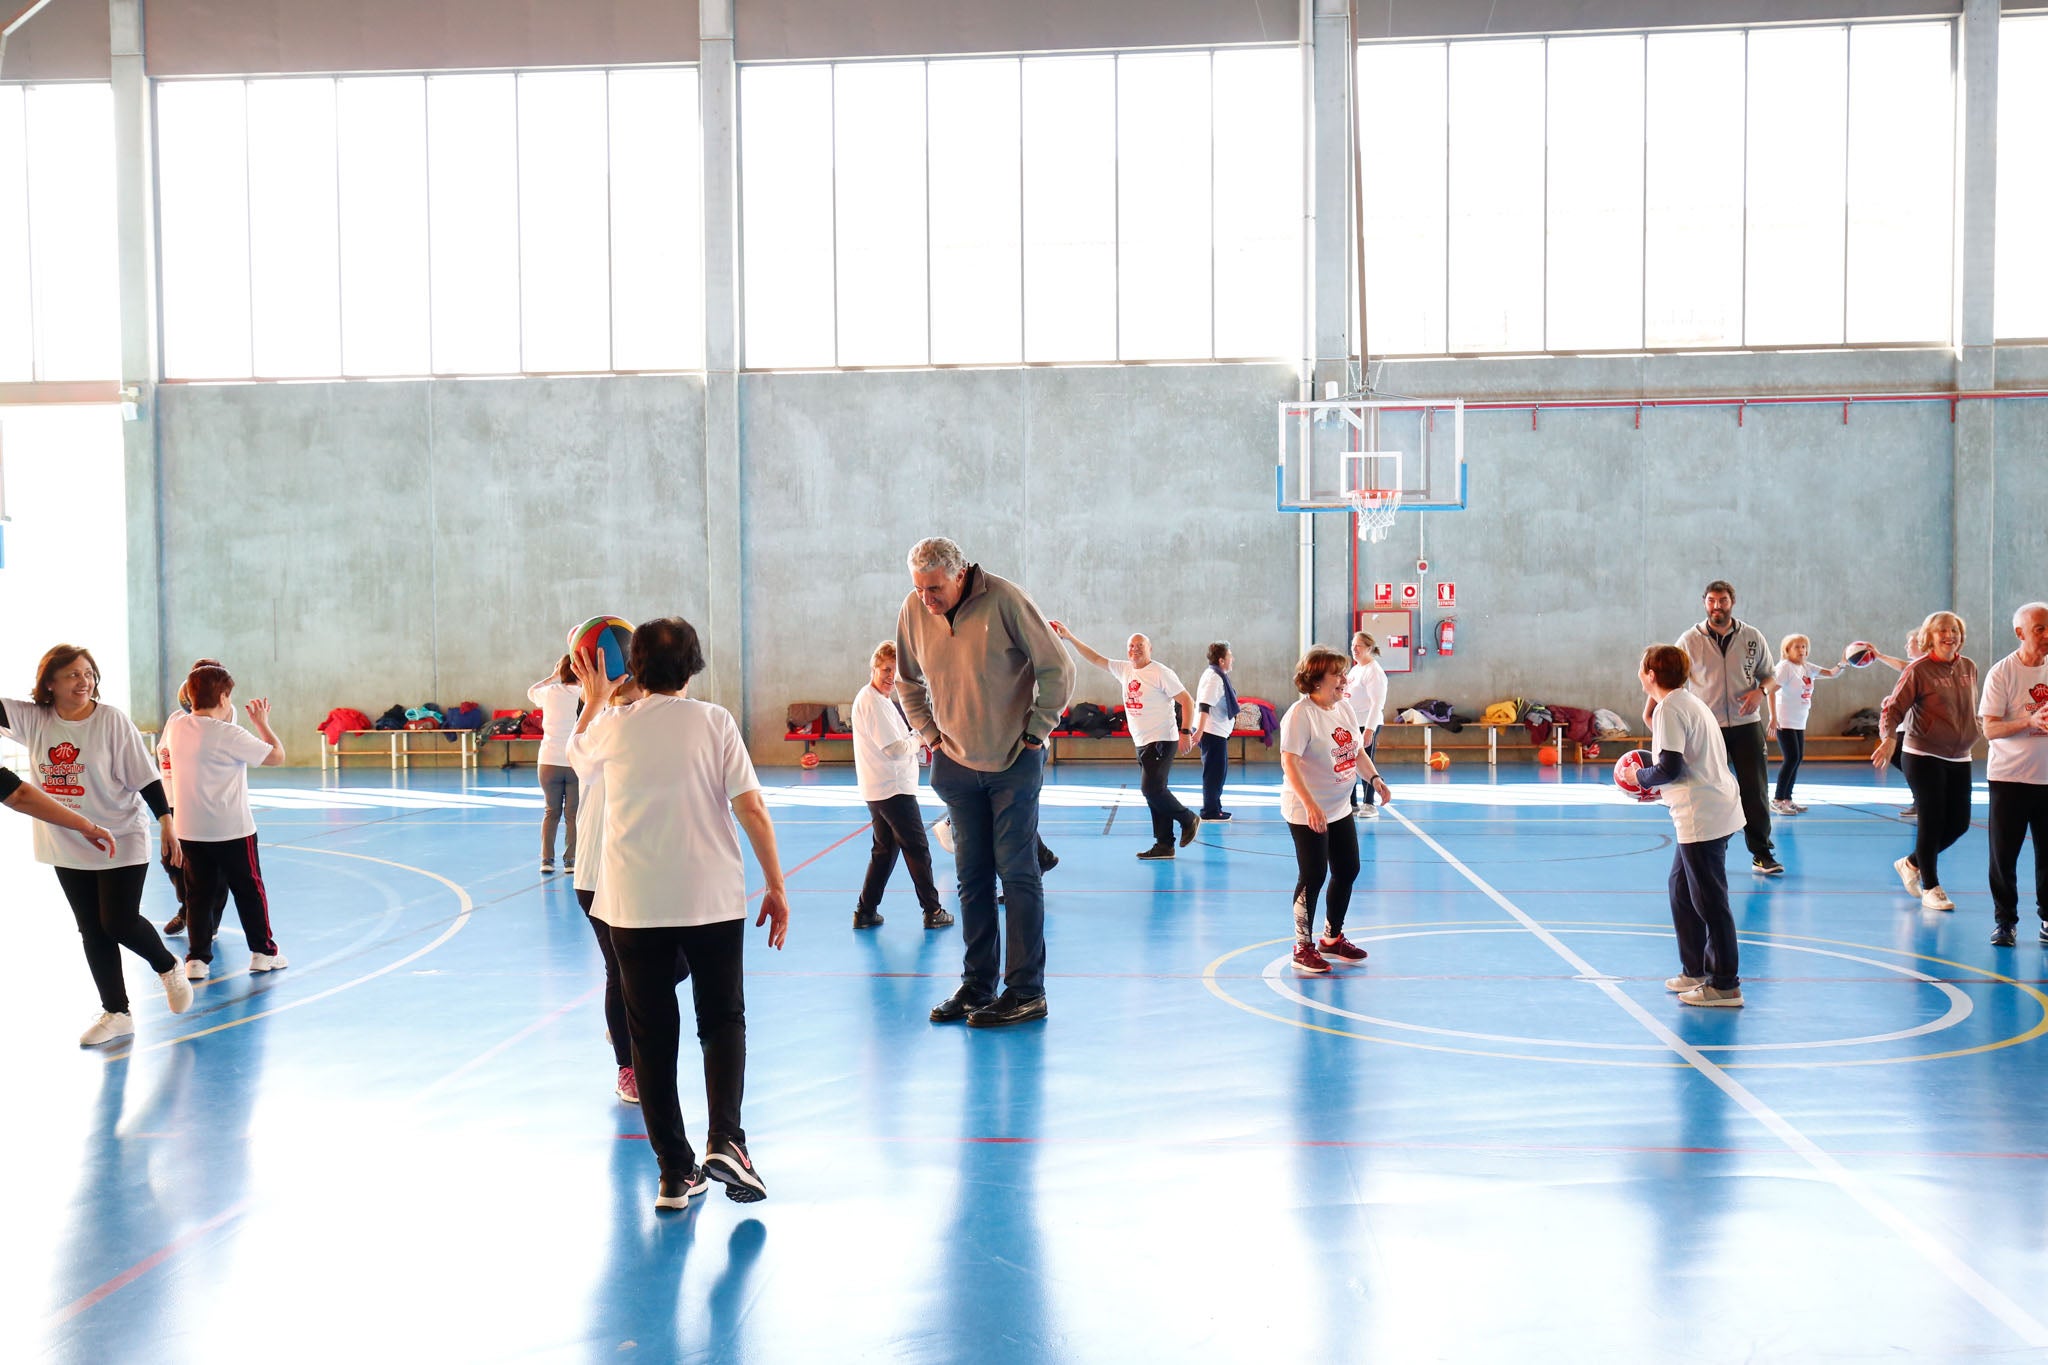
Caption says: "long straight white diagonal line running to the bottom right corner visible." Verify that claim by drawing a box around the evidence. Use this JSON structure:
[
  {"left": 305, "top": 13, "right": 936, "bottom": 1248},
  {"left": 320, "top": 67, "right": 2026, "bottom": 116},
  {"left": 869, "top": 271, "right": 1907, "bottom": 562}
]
[{"left": 1386, "top": 806, "right": 2048, "bottom": 1349}]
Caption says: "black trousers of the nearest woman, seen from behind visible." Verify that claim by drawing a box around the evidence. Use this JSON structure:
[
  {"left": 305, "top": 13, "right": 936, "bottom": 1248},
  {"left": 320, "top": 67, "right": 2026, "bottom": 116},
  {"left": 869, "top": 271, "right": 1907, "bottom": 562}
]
[{"left": 612, "top": 919, "right": 748, "bottom": 1179}]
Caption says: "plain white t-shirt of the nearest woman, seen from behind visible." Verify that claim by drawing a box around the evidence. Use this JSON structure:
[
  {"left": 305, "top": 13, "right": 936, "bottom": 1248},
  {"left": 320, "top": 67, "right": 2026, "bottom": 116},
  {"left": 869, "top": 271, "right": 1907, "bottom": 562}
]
[{"left": 569, "top": 696, "right": 760, "bottom": 929}]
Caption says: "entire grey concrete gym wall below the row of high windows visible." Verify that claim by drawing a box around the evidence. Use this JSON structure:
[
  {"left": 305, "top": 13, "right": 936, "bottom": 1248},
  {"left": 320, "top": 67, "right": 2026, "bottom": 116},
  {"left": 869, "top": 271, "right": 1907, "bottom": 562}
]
[{"left": 144, "top": 352, "right": 2048, "bottom": 759}]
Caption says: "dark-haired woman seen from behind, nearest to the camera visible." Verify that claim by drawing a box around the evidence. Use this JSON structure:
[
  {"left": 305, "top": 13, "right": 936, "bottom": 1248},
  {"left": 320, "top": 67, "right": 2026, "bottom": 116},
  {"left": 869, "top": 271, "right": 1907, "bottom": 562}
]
[{"left": 569, "top": 616, "right": 788, "bottom": 1209}]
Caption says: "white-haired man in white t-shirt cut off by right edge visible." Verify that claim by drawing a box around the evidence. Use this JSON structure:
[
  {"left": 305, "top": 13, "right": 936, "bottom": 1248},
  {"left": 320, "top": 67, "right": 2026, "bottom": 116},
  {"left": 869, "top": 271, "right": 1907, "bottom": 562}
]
[{"left": 1976, "top": 602, "right": 2048, "bottom": 948}]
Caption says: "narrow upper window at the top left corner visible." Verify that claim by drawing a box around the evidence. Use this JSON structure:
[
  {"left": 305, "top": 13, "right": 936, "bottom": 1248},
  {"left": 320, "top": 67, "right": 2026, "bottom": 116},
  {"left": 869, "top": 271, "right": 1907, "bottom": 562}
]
[{"left": 0, "top": 84, "right": 121, "bottom": 381}]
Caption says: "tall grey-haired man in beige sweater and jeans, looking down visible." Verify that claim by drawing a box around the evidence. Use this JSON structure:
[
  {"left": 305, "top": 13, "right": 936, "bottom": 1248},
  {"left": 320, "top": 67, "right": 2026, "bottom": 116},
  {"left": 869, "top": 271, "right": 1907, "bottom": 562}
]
[{"left": 897, "top": 536, "right": 1073, "bottom": 1027}]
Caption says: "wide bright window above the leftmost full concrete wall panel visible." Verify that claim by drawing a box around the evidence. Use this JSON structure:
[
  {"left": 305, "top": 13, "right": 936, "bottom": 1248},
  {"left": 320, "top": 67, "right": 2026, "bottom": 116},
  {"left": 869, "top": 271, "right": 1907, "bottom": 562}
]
[{"left": 149, "top": 68, "right": 702, "bottom": 379}]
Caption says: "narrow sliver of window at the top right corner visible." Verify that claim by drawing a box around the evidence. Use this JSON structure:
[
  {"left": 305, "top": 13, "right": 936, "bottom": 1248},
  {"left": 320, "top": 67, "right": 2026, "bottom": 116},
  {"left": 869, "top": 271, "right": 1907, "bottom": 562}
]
[{"left": 1993, "top": 16, "right": 2048, "bottom": 338}]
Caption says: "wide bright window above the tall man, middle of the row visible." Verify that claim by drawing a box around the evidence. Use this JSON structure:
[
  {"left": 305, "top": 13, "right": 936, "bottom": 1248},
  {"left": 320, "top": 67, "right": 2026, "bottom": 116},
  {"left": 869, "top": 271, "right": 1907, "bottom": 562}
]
[{"left": 739, "top": 49, "right": 1300, "bottom": 368}]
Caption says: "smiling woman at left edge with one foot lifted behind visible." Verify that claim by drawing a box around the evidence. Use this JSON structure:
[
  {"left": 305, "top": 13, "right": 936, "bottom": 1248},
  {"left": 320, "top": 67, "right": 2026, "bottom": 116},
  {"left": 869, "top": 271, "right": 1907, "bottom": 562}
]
[{"left": 0, "top": 645, "right": 193, "bottom": 1048}]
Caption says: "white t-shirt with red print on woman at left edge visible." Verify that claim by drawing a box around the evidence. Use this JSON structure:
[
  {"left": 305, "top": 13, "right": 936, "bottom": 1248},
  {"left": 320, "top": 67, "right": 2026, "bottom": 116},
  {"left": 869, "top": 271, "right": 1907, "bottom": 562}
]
[{"left": 0, "top": 698, "right": 160, "bottom": 872}]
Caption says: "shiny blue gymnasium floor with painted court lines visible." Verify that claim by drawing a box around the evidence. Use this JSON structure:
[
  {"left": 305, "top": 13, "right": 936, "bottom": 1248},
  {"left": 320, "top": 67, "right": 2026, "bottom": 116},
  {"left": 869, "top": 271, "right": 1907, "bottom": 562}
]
[{"left": 0, "top": 763, "right": 2048, "bottom": 1365}]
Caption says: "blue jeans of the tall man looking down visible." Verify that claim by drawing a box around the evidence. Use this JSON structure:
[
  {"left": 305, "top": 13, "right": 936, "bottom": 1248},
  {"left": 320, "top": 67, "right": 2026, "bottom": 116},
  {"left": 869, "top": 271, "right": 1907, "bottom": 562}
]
[{"left": 932, "top": 749, "right": 1044, "bottom": 1001}]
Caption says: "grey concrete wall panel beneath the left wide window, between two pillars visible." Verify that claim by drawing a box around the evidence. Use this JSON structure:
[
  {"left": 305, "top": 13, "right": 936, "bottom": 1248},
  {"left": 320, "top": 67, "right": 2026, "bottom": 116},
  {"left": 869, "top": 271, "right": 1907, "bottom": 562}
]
[{"left": 160, "top": 377, "right": 705, "bottom": 761}]
